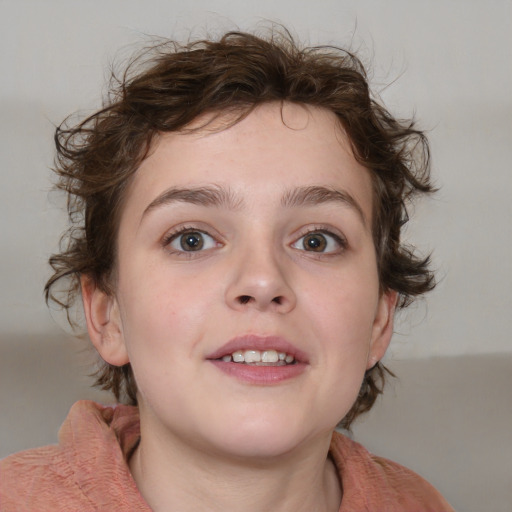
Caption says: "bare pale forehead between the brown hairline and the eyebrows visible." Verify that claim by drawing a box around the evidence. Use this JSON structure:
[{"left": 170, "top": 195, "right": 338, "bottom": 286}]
[{"left": 125, "top": 103, "right": 372, "bottom": 223}]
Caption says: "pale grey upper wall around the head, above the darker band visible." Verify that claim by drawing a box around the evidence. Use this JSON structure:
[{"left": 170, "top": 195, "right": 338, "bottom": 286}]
[{"left": 0, "top": 0, "right": 512, "bottom": 358}]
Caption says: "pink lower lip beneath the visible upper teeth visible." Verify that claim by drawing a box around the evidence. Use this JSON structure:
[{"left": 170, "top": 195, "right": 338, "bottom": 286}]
[{"left": 210, "top": 359, "right": 306, "bottom": 385}]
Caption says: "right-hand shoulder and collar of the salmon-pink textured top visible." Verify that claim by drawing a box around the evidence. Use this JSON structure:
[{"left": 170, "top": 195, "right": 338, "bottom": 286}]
[{"left": 330, "top": 433, "right": 453, "bottom": 512}]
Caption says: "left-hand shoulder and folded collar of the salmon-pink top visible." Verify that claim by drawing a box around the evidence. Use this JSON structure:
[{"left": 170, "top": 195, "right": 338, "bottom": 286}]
[{"left": 0, "top": 401, "right": 149, "bottom": 512}]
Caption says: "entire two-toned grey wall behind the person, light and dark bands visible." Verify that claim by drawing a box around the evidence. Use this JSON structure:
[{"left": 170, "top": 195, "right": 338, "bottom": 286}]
[{"left": 0, "top": 0, "right": 512, "bottom": 512}]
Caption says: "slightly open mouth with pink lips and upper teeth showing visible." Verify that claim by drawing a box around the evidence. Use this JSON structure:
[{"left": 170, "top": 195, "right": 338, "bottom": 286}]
[{"left": 207, "top": 335, "right": 308, "bottom": 384}]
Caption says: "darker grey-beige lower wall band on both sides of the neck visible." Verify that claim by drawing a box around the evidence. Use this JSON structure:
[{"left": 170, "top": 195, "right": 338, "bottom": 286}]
[{"left": 4, "top": 336, "right": 512, "bottom": 512}]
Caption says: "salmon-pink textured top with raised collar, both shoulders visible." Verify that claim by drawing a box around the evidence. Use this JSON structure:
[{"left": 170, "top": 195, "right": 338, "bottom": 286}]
[{"left": 0, "top": 401, "right": 453, "bottom": 512}]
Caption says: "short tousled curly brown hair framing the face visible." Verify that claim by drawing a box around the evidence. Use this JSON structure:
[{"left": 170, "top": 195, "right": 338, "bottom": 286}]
[{"left": 45, "top": 28, "right": 434, "bottom": 427}]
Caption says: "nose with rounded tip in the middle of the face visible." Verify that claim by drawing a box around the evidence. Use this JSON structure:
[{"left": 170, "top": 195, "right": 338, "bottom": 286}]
[{"left": 226, "top": 243, "right": 297, "bottom": 314}]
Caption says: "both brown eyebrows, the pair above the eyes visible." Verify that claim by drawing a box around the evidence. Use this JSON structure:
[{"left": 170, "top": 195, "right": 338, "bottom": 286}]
[{"left": 142, "top": 185, "right": 367, "bottom": 226}]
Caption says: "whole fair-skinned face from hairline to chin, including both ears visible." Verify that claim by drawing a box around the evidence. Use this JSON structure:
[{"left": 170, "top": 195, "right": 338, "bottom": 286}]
[{"left": 84, "top": 104, "right": 394, "bottom": 456}]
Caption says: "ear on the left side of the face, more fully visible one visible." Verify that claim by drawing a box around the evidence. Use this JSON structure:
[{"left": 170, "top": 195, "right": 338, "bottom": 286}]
[{"left": 80, "top": 275, "right": 129, "bottom": 366}]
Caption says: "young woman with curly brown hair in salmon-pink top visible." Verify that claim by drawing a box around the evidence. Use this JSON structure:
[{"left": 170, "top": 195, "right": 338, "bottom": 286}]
[{"left": 0, "top": 29, "right": 452, "bottom": 512}]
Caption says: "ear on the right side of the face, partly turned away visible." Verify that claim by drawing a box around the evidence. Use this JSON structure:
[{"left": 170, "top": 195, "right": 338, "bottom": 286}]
[{"left": 366, "top": 290, "right": 398, "bottom": 370}]
